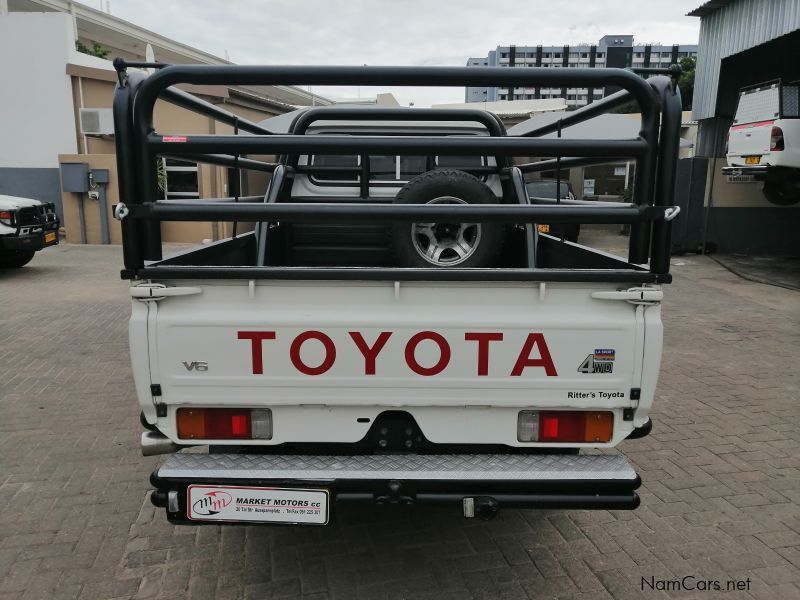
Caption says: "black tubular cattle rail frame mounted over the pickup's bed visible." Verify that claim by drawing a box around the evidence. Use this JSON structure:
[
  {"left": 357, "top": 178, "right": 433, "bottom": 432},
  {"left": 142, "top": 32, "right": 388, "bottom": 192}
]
[{"left": 114, "top": 59, "right": 681, "bottom": 283}]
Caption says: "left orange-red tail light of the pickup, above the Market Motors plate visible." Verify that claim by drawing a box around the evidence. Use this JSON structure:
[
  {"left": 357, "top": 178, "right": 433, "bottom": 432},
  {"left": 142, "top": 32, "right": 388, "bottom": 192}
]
[{"left": 176, "top": 408, "right": 272, "bottom": 440}]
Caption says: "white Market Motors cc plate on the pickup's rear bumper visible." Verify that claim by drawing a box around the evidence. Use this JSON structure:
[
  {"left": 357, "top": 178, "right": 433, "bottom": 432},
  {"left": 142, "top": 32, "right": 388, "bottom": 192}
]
[{"left": 186, "top": 485, "right": 329, "bottom": 525}]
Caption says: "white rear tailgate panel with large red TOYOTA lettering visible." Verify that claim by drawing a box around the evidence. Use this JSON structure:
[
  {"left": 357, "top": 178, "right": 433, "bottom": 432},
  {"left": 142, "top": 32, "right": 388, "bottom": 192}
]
[{"left": 138, "top": 281, "right": 661, "bottom": 445}]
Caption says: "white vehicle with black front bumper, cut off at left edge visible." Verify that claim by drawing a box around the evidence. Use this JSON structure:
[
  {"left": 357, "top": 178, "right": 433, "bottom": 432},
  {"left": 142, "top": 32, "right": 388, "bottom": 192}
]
[{"left": 0, "top": 194, "right": 61, "bottom": 269}]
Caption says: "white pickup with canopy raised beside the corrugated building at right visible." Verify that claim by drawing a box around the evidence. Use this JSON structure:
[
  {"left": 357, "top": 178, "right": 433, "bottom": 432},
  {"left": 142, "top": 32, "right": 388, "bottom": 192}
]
[{"left": 722, "top": 81, "right": 800, "bottom": 206}]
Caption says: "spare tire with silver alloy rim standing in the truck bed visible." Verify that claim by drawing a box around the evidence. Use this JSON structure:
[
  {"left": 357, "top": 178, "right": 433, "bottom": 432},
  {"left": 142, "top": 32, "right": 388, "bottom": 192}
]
[{"left": 391, "top": 169, "right": 506, "bottom": 268}]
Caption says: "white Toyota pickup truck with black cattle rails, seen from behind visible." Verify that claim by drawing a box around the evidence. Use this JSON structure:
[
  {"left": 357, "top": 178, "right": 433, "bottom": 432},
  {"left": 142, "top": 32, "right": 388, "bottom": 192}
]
[{"left": 114, "top": 59, "right": 680, "bottom": 525}]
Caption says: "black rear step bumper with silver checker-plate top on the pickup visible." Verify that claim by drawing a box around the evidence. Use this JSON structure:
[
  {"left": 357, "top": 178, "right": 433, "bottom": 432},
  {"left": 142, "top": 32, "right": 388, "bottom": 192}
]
[{"left": 151, "top": 454, "right": 641, "bottom": 524}]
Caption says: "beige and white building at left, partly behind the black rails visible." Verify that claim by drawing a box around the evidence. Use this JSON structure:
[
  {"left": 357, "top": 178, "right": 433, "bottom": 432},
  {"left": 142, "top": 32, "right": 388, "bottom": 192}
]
[{"left": 0, "top": 0, "right": 332, "bottom": 243}]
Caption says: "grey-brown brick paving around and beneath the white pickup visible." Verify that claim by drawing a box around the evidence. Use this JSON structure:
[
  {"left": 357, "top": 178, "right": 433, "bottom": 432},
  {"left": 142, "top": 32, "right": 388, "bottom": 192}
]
[{"left": 0, "top": 240, "right": 800, "bottom": 600}]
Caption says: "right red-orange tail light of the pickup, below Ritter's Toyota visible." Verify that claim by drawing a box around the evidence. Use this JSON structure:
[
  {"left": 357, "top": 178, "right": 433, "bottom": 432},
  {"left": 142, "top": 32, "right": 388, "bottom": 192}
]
[{"left": 517, "top": 410, "right": 614, "bottom": 443}]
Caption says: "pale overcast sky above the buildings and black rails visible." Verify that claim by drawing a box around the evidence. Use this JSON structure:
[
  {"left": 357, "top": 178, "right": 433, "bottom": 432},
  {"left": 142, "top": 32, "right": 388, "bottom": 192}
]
[{"left": 103, "top": 0, "right": 703, "bottom": 107}]
